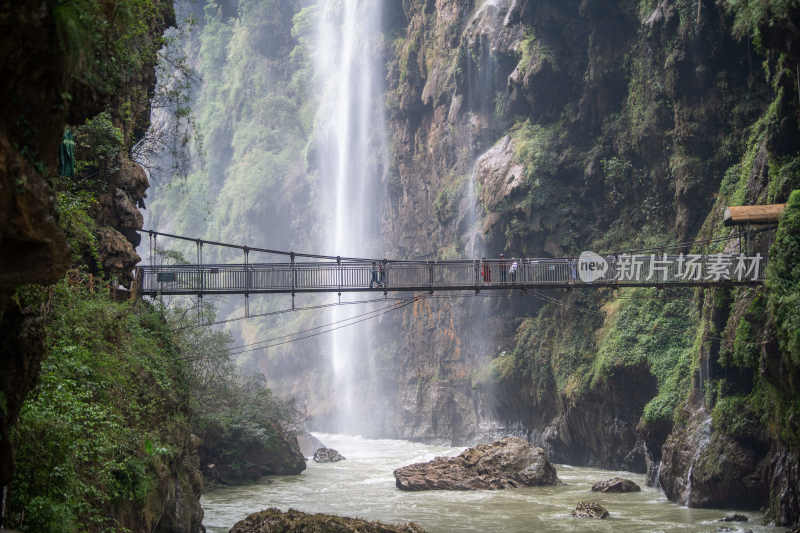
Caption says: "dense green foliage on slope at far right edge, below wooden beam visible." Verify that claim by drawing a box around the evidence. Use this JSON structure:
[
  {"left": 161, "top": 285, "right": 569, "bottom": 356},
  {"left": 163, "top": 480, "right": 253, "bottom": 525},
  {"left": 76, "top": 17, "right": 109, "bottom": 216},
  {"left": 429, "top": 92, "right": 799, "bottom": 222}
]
[{"left": 713, "top": 191, "right": 800, "bottom": 446}]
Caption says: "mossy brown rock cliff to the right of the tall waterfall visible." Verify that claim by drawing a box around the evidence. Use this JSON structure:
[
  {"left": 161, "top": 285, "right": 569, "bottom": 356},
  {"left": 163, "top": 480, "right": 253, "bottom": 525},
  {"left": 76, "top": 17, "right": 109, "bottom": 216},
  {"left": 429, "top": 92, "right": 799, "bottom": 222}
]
[{"left": 384, "top": 0, "right": 800, "bottom": 524}]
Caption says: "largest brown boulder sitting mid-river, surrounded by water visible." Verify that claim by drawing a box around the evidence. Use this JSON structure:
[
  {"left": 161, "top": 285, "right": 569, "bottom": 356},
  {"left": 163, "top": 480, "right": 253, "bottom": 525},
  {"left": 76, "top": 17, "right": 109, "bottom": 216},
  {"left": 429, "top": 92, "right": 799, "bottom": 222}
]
[{"left": 394, "top": 437, "right": 560, "bottom": 490}]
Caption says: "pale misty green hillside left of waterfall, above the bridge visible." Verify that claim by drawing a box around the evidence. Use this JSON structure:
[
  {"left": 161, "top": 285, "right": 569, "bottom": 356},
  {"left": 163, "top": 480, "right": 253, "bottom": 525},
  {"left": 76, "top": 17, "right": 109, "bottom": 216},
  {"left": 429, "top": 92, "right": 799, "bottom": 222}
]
[{"left": 149, "top": 0, "right": 310, "bottom": 251}]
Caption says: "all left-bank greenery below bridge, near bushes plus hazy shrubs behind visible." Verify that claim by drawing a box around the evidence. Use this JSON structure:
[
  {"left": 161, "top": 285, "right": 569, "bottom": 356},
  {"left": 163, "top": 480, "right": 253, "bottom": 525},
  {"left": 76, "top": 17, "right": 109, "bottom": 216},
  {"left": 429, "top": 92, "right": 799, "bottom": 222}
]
[{"left": 9, "top": 278, "right": 304, "bottom": 533}]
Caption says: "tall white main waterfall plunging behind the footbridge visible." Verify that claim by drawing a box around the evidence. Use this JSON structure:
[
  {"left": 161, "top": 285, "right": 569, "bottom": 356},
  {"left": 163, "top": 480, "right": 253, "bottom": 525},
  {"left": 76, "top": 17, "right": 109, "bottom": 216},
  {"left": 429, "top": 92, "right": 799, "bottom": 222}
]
[{"left": 315, "top": 0, "right": 387, "bottom": 432}]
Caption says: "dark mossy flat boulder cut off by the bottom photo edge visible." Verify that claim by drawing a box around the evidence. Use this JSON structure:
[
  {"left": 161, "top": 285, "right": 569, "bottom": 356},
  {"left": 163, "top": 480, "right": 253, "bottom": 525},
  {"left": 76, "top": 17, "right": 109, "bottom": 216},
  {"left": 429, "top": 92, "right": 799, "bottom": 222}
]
[{"left": 230, "top": 508, "right": 425, "bottom": 533}]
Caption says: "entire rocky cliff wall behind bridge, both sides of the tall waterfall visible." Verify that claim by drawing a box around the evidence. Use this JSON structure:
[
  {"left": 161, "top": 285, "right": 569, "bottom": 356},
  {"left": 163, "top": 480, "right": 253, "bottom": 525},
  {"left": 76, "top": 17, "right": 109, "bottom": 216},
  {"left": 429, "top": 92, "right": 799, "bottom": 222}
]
[{"left": 139, "top": 0, "right": 800, "bottom": 523}]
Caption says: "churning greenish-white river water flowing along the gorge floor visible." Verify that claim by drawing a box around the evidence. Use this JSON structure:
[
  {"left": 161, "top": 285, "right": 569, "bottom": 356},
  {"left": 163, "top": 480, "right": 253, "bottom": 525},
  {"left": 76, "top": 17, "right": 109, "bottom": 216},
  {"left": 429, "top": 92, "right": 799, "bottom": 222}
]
[{"left": 203, "top": 434, "right": 784, "bottom": 533}]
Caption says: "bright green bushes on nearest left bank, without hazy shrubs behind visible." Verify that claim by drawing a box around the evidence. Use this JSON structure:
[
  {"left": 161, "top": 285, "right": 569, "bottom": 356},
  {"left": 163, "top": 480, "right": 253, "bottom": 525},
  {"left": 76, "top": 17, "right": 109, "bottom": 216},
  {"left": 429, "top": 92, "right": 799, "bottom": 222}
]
[{"left": 9, "top": 280, "right": 189, "bottom": 533}]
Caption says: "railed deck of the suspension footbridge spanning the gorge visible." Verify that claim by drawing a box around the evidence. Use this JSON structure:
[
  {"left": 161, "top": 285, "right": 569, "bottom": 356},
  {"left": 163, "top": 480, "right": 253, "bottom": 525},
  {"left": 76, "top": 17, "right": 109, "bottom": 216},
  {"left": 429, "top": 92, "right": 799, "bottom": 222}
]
[{"left": 136, "top": 254, "right": 765, "bottom": 296}]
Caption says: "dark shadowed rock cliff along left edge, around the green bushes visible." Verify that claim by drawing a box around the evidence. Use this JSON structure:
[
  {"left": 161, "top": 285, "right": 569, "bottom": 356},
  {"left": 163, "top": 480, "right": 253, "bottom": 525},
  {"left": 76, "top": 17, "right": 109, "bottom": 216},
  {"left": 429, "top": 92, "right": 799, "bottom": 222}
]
[{"left": 0, "top": 1, "right": 212, "bottom": 531}]
